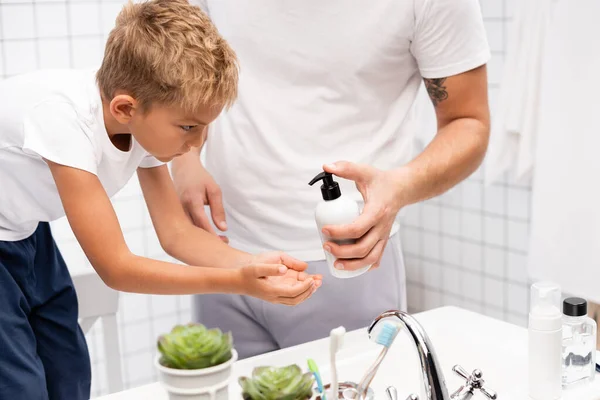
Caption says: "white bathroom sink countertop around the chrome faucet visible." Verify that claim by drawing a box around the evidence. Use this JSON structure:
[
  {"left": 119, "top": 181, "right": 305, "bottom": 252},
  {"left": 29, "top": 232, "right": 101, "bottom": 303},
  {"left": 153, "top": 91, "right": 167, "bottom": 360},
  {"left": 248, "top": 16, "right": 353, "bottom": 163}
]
[{"left": 99, "top": 307, "right": 600, "bottom": 400}]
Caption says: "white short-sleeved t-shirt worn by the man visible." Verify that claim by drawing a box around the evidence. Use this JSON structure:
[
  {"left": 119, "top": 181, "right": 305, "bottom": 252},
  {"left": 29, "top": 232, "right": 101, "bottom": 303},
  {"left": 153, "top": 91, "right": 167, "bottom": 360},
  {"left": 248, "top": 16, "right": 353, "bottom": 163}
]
[{"left": 196, "top": 0, "right": 490, "bottom": 261}]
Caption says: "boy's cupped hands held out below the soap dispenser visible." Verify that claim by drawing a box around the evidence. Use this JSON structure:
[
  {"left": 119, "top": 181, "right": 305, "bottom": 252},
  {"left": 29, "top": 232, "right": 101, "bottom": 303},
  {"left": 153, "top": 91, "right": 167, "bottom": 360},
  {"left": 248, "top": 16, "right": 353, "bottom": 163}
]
[{"left": 239, "top": 252, "right": 323, "bottom": 306}]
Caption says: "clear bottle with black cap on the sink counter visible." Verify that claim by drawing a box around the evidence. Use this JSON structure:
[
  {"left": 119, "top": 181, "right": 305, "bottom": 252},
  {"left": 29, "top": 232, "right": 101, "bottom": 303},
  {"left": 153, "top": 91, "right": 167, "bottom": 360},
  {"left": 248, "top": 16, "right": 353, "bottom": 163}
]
[{"left": 562, "top": 297, "right": 597, "bottom": 389}]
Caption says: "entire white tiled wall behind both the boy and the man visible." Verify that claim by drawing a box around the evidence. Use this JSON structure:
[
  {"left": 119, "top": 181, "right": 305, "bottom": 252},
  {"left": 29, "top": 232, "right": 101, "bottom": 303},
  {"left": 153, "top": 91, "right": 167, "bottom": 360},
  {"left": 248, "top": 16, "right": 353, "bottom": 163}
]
[{"left": 0, "top": 0, "right": 531, "bottom": 395}]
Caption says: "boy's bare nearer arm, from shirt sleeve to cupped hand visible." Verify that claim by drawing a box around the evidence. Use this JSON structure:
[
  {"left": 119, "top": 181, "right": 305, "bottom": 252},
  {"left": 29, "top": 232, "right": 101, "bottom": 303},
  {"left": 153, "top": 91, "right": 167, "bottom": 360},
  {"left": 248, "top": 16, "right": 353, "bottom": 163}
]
[{"left": 46, "top": 160, "right": 314, "bottom": 304}]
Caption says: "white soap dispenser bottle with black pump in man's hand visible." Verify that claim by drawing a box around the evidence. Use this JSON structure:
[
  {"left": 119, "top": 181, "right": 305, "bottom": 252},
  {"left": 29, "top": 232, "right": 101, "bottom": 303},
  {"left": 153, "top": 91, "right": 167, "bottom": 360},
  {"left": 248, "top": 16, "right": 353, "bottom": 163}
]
[{"left": 309, "top": 172, "right": 371, "bottom": 278}]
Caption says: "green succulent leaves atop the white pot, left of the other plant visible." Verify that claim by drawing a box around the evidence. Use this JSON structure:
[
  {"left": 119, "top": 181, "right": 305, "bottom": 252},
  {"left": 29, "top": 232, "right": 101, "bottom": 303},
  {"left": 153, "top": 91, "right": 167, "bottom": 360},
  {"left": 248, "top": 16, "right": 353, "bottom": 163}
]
[{"left": 157, "top": 324, "right": 233, "bottom": 369}]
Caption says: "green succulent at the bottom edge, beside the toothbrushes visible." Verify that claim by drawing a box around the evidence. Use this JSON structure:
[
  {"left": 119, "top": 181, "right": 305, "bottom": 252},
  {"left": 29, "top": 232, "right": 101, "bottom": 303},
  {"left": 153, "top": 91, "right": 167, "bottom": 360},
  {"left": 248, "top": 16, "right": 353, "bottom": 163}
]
[{"left": 239, "top": 364, "right": 314, "bottom": 400}]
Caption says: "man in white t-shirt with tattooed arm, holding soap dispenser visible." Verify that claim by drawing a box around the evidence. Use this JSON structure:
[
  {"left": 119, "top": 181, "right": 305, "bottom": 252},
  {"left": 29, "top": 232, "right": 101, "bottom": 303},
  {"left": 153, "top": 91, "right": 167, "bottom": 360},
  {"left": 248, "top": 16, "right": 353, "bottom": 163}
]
[{"left": 173, "top": 0, "right": 490, "bottom": 357}]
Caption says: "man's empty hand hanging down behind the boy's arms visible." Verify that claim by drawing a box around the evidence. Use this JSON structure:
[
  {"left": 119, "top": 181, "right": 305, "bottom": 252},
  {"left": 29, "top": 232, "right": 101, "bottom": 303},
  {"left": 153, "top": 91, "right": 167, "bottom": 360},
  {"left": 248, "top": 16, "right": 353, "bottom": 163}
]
[{"left": 171, "top": 152, "right": 229, "bottom": 243}]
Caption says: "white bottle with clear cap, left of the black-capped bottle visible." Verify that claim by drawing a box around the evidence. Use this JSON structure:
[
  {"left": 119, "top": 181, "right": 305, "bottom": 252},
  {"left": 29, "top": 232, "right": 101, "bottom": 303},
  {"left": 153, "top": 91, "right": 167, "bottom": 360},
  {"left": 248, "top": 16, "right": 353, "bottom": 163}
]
[{"left": 529, "top": 282, "right": 562, "bottom": 400}]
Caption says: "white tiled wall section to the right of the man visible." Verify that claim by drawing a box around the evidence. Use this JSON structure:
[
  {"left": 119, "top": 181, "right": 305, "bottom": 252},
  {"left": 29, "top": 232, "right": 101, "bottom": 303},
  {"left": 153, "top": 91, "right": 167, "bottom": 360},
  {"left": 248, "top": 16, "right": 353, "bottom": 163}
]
[{"left": 402, "top": 0, "right": 531, "bottom": 325}]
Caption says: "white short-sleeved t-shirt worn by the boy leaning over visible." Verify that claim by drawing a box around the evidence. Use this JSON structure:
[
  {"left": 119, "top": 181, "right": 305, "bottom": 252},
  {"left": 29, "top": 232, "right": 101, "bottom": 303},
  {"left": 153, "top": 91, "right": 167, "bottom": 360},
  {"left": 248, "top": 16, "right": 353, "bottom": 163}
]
[{"left": 0, "top": 70, "right": 162, "bottom": 241}]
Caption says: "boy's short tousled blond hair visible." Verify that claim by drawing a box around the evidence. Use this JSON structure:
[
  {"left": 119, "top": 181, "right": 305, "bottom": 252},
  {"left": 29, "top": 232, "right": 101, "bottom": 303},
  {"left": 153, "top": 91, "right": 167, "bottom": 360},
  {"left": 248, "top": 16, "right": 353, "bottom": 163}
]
[{"left": 96, "top": 0, "right": 238, "bottom": 112}]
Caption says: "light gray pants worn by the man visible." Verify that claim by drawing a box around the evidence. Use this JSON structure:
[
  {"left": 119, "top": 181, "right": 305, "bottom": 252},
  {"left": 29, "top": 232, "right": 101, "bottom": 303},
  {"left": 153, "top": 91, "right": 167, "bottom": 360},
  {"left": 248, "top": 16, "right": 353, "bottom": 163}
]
[{"left": 192, "top": 233, "right": 406, "bottom": 358}]
